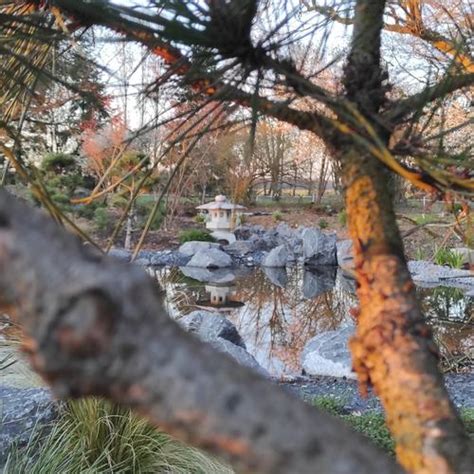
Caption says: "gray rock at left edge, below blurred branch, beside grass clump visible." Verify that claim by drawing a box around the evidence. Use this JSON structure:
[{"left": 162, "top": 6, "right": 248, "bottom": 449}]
[{"left": 0, "top": 386, "right": 59, "bottom": 464}]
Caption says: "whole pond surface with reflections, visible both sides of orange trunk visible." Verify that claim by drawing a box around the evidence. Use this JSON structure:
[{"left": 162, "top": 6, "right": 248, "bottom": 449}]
[{"left": 148, "top": 267, "right": 474, "bottom": 377}]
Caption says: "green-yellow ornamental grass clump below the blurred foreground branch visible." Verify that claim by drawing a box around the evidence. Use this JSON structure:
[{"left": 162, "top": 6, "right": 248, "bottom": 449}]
[{"left": 4, "top": 398, "right": 232, "bottom": 474}]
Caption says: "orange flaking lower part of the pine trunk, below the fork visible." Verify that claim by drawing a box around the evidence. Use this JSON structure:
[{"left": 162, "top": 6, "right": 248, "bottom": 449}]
[{"left": 343, "top": 150, "right": 473, "bottom": 474}]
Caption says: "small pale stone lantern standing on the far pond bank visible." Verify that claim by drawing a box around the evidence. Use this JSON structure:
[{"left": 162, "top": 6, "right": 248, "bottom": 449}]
[{"left": 196, "top": 194, "right": 245, "bottom": 243}]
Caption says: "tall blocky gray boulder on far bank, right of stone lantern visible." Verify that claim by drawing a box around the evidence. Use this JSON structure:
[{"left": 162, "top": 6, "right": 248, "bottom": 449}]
[{"left": 301, "top": 228, "right": 337, "bottom": 265}]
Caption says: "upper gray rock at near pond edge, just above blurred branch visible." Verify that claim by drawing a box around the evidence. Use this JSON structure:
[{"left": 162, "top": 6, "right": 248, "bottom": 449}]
[{"left": 178, "top": 311, "right": 246, "bottom": 349}]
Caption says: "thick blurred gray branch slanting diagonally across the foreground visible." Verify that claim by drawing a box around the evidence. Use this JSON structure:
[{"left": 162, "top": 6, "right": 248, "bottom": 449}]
[{"left": 0, "top": 190, "right": 400, "bottom": 474}]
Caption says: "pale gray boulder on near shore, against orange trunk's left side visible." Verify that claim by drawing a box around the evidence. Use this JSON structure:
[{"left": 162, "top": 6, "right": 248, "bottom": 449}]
[{"left": 301, "top": 325, "right": 355, "bottom": 378}]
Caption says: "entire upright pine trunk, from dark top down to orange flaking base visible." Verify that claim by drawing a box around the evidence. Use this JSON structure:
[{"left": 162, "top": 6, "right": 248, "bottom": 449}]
[{"left": 333, "top": 0, "right": 472, "bottom": 466}]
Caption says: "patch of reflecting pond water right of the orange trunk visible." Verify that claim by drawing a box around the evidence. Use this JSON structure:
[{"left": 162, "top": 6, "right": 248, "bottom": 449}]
[{"left": 418, "top": 287, "right": 474, "bottom": 366}]
